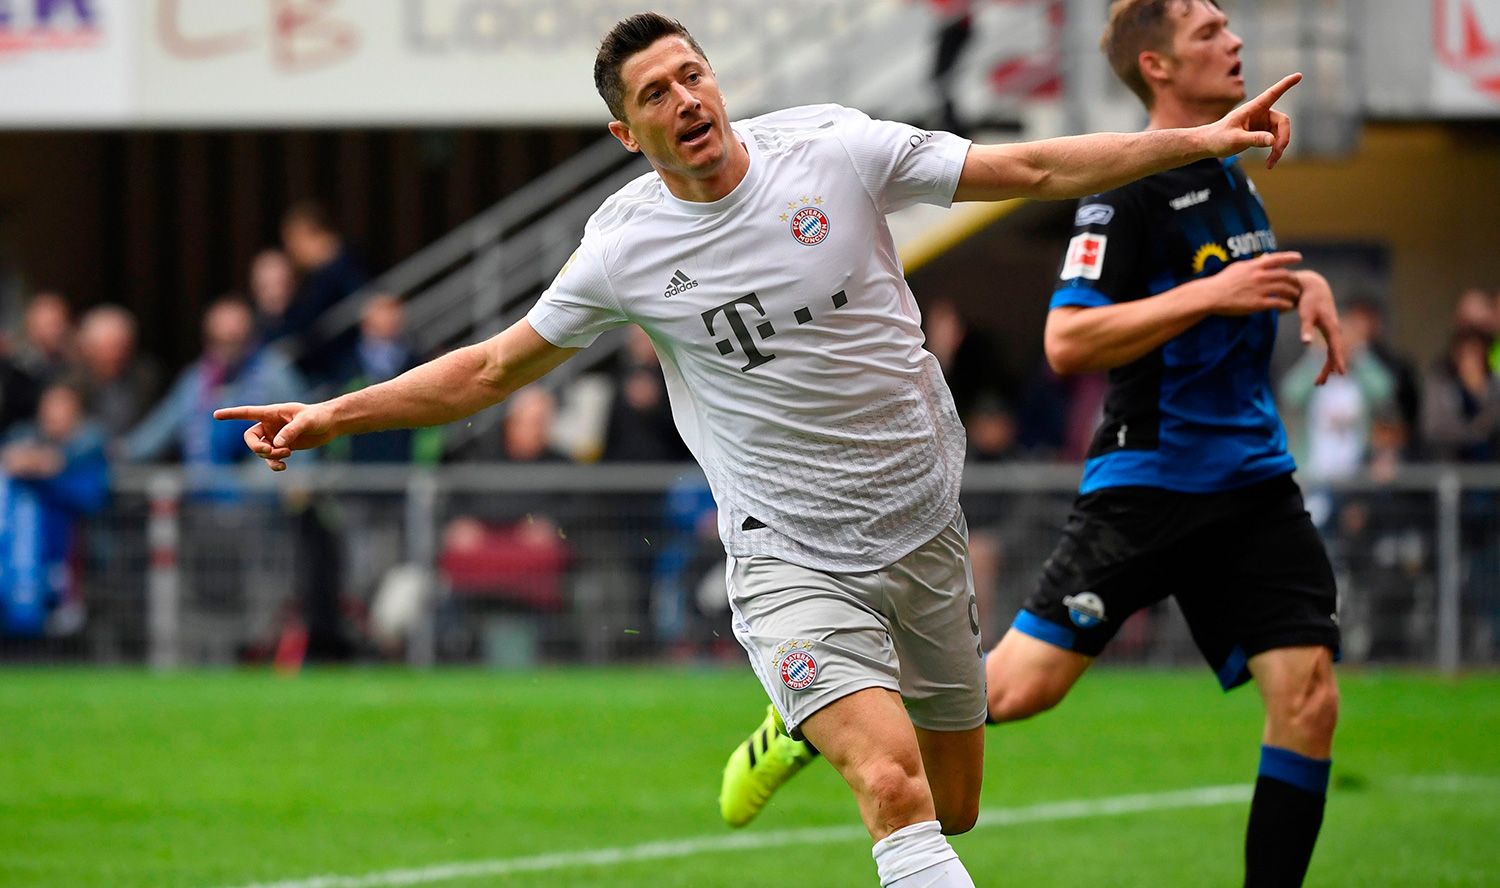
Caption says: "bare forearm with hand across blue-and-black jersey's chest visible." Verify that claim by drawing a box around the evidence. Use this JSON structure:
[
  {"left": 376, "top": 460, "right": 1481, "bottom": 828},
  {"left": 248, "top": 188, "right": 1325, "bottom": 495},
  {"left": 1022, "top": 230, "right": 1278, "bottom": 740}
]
[{"left": 1043, "top": 252, "right": 1302, "bottom": 374}]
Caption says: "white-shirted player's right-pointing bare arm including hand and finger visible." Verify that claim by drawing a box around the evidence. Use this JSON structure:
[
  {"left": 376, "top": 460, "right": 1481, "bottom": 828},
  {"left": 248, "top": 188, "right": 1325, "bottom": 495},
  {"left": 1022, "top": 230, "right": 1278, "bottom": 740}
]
[{"left": 953, "top": 74, "right": 1302, "bottom": 201}]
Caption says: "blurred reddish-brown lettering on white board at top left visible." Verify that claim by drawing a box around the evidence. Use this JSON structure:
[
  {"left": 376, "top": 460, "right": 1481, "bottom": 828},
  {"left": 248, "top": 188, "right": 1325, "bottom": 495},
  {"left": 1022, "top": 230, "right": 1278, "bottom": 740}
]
[{"left": 156, "top": 0, "right": 359, "bottom": 72}]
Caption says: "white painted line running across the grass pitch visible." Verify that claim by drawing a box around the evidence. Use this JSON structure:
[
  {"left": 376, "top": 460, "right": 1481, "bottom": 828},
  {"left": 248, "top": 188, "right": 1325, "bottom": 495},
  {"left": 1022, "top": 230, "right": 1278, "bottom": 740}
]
[{"left": 219, "top": 785, "right": 1253, "bottom": 888}]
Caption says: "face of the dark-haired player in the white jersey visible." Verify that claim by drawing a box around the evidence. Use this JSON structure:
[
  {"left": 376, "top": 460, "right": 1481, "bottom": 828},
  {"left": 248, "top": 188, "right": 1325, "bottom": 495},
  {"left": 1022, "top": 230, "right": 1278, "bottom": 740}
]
[{"left": 609, "top": 36, "right": 734, "bottom": 194}]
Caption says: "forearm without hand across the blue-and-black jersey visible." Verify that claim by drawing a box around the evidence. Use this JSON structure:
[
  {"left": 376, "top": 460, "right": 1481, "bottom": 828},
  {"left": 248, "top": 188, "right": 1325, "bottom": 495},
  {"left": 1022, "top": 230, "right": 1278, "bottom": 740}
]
[{"left": 1044, "top": 284, "right": 1209, "bottom": 375}]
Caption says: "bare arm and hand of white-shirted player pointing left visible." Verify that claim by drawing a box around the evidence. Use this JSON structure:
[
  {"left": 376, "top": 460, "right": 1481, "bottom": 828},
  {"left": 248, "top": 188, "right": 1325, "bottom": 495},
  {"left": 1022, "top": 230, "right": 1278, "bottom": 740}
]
[{"left": 213, "top": 320, "right": 578, "bottom": 471}]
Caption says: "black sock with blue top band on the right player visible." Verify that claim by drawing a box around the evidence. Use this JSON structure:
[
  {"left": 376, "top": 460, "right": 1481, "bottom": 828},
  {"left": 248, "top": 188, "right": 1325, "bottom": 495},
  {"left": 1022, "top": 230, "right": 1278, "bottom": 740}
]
[{"left": 1245, "top": 746, "right": 1334, "bottom": 888}]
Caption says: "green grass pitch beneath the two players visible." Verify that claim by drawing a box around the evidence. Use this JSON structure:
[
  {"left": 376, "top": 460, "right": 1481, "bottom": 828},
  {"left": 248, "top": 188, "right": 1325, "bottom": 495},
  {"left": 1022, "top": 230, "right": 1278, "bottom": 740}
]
[{"left": 0, "top": 669, "right": 1500, "bottom": 888}]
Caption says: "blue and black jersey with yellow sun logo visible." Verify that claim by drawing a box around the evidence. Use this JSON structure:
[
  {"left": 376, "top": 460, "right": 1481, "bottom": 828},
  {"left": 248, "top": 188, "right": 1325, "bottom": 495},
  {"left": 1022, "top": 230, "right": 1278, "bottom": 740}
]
[{"left": 1052, "top": 159, "right": 1295, "bottom": 494}]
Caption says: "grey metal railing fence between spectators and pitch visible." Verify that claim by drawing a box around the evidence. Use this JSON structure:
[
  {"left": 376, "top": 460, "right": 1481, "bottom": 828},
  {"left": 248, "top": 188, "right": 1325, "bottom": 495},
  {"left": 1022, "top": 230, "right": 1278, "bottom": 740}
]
[{"left": 0, "top": 464, "right": 1500, "bottom": 672}]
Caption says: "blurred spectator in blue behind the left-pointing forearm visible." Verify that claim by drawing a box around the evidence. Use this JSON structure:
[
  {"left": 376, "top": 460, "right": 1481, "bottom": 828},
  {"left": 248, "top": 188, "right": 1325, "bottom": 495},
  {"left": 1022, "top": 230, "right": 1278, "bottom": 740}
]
[{"left": 326, "top": 294, "right": 443, "bottom": 465}]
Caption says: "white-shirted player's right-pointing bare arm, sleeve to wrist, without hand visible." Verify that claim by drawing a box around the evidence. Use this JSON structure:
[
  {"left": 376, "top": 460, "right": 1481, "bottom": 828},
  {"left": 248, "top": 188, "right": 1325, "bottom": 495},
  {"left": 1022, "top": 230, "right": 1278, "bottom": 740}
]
[{"left": 954, "top": 129, "right": 1214, "bottom": 201}]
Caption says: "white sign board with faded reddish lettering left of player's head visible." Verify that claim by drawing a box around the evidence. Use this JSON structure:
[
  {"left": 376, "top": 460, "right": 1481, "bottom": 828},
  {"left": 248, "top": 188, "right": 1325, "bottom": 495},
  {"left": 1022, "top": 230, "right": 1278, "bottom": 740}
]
[{"left": 137, "top": 0, "right": 606, "bottom": 126}]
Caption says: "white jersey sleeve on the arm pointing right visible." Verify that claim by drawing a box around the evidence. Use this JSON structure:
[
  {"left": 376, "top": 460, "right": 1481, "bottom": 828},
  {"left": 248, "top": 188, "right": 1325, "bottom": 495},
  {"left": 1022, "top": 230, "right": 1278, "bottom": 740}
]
[{"left": 837, "top": 108, "right": 971, "bottom": 213}]
